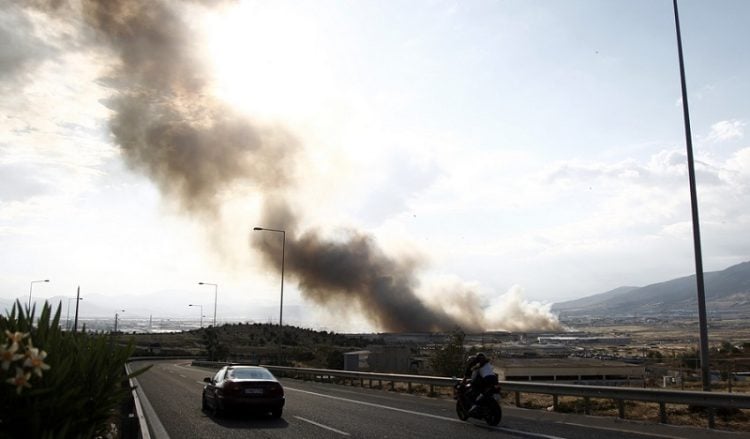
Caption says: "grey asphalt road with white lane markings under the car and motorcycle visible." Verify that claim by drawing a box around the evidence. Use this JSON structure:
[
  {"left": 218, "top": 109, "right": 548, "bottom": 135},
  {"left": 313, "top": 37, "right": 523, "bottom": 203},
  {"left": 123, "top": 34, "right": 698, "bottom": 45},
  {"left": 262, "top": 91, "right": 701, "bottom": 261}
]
[{"left": 131, "top": 360, "right": 747, "bottom": 439}]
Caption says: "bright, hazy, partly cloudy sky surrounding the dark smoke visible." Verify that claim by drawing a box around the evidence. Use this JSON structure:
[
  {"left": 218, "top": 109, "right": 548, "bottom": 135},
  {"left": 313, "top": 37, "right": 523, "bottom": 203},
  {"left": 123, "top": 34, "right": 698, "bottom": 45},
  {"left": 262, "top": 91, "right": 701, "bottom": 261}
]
[{"left": 0, "top": 0, "right": 750, "bottom": 329}]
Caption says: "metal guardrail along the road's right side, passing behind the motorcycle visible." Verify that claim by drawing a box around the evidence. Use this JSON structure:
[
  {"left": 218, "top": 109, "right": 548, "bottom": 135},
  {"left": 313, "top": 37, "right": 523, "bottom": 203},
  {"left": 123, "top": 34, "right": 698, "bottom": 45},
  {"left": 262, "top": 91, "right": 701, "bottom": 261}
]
[{"left": 264, "top": 365, "right": 750, "bottom": 428}]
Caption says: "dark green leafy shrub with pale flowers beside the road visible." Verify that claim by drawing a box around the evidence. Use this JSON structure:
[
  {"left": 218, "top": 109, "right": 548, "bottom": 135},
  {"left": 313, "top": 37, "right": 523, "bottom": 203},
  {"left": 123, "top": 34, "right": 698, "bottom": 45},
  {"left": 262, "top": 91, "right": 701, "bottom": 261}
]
[{"left": 0, "top": 302, "right": 143, "bottom": 439}]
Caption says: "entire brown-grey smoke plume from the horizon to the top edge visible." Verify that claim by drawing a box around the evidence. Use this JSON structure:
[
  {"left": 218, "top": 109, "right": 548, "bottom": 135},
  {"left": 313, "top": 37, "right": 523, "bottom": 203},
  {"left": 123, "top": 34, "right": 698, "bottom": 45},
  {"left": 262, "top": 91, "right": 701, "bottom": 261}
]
[{"left": 29, "top": 0, "right": 560, "bottom": 331}]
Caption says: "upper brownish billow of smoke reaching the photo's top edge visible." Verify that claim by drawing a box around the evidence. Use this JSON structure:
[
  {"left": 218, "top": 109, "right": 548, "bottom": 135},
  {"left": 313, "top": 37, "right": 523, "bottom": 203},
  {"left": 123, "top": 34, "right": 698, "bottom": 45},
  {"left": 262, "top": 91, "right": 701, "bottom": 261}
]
[{"left": 79, "top": 1, "right": 297, "bottom": 216}]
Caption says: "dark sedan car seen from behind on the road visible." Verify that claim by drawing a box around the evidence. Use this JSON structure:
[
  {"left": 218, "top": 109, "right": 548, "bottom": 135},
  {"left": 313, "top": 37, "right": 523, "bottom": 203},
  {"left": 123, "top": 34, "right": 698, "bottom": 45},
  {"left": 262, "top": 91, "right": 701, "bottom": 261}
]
[{"left": 202, "top": 365, "right": 285, "bottom": 418}]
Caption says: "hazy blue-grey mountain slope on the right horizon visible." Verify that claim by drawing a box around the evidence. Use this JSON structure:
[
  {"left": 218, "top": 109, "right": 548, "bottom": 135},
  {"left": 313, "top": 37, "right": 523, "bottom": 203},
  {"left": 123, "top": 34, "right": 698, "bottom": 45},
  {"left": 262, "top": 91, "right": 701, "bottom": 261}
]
[{"left": 552, "top": 262, "right": 750, "bottom": 318}]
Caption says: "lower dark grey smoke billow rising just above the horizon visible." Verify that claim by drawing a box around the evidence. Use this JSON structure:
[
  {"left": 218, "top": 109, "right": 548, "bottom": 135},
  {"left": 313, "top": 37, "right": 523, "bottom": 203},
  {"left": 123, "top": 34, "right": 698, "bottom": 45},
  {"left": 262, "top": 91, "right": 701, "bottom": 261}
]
[{"left": 253, "top": 200, "right": 481, "bottom": 332}]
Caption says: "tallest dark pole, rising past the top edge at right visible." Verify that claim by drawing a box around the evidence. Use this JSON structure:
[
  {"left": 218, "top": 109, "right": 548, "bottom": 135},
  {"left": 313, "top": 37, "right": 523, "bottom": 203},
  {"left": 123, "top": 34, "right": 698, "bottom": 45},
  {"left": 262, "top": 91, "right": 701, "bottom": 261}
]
[{"left": 672, "top": 0, "right": 711, "bottom": 392}]
